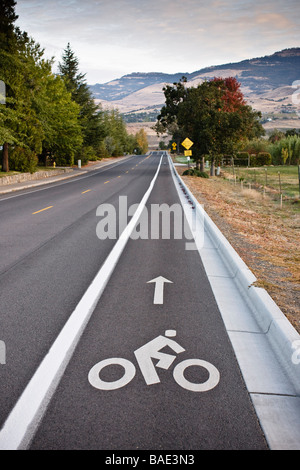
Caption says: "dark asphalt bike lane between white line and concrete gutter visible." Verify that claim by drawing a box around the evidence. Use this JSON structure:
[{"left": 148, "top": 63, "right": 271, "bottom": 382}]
[{"left": 30, "top": 153, "right": 267, "bottom": 450}]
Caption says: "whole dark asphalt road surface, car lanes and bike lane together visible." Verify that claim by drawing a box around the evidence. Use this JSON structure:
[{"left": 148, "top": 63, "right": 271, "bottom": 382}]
[{"left": 0, "top": 152, "right": 268, "bottom": 450}]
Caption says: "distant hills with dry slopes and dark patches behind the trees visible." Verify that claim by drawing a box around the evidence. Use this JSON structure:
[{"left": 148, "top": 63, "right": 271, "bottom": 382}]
[{"left": 90, "top": 48, "right": 300, "bottom": 147}]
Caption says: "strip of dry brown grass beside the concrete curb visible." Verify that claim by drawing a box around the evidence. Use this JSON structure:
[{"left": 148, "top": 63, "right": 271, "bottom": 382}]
[{"left": 178, "top": 167, "right": 300, "bottom": 333}]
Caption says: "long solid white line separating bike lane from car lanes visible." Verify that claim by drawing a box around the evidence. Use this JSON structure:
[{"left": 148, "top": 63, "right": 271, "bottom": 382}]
[{"left": 0, "top": 157, "right": 163, "bottom": 450}]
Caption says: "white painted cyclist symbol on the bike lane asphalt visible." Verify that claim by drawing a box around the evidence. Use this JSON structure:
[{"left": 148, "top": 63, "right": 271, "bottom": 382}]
[{"left": 88, "top": 330, "right": 220, "bottom": 392}]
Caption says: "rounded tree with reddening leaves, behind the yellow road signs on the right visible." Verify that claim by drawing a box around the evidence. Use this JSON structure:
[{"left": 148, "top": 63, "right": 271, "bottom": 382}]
[{"left": 157, "top": 77, "right": 264, "bottom": 171}]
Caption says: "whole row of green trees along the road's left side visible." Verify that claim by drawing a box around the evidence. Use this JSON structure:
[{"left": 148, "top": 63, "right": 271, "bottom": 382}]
[{"left": 0, "top": 17, "right": 137, "bottom": 171}]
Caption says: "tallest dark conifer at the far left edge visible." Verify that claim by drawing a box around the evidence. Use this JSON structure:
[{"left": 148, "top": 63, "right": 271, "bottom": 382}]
[{"left": 0, "top": 1, "right": 43, "bottom": 171}]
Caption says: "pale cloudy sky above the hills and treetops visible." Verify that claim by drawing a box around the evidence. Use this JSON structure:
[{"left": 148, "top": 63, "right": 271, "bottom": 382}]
[{"left": 16, "top": 0, "right": 300, "bottom": 85}]
